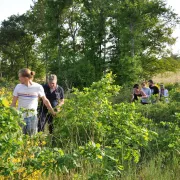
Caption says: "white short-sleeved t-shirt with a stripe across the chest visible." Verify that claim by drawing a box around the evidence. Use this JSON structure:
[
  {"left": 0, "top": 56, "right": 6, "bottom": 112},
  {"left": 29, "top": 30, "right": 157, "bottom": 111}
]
[{"left": 13, "top": 82, "right": 45, "bottom": 117}]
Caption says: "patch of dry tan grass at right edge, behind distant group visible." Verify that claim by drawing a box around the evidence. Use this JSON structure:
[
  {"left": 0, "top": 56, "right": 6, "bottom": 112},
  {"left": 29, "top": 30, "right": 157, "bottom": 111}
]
[{"left": 153, "top": 71, "right": 180, "bottom": 84}]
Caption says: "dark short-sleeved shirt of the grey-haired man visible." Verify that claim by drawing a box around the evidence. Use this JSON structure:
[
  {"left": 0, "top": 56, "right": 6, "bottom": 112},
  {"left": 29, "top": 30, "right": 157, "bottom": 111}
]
[{"left": 40, "top": 84, "right": 64, "bottom": 112}]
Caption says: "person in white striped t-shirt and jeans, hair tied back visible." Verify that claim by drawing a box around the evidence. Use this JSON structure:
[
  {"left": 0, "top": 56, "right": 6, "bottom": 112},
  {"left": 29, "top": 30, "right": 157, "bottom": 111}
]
[{"left": 11, "top": 68, "right": 55, "bottom": 136}]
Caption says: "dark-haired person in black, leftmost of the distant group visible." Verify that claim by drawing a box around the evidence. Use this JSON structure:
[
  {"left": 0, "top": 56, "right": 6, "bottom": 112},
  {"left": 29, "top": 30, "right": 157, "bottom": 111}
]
[{"left": 131, "top": 84, "right": 147, "bottom": 103}]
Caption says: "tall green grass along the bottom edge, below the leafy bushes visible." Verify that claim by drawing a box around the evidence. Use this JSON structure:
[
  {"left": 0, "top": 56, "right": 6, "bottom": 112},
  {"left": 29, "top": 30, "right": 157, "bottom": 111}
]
[{"left": 42, "top": 155, "right": 180, "bottom": 180}]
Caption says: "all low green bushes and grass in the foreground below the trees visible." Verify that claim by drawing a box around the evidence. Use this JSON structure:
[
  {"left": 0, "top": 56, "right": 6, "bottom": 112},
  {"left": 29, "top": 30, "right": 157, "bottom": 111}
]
[{"left": 0, "top": 74, "right": 180, "bottom": 179}]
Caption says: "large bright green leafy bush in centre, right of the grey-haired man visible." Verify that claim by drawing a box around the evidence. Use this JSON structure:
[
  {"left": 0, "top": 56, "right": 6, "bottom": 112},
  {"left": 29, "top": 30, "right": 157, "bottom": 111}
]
[{"left": 54, "top": 74, "right": 156, "bottom": 176}]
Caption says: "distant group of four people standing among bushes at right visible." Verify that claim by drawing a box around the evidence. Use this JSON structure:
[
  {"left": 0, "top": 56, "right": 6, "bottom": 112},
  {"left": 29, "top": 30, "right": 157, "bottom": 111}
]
[{"left": 131, "top": 80, "right": 169, "bottom": 104}]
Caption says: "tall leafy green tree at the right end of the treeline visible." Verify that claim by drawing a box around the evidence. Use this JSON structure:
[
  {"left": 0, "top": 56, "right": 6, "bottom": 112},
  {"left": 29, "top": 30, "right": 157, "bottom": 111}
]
[{"left": 109, "top": 0, "right": 178, "bottom": 84}]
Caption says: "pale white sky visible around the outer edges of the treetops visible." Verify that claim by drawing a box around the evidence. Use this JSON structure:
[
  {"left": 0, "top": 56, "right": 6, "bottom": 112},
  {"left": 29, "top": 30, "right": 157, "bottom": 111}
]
[{"left": 0, "top": 0, "right": 180, "bottom": 54}]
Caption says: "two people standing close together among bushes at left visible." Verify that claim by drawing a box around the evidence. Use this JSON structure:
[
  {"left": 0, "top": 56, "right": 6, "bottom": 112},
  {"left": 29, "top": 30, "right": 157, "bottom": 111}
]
[{"left": 11, "top": 68, "right": 64, "bottom": 135}]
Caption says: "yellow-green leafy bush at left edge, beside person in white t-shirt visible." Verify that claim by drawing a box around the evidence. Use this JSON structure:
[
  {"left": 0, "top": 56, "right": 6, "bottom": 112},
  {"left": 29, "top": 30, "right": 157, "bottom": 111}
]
[{"left": 0, "top": 99, "right": 22, "bottom": 175}]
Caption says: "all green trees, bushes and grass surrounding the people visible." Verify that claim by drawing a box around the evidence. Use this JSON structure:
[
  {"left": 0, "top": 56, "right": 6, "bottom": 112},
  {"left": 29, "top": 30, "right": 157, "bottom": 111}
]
[{"left": 0, "top": 0, "right": 180, "bottom": 180}]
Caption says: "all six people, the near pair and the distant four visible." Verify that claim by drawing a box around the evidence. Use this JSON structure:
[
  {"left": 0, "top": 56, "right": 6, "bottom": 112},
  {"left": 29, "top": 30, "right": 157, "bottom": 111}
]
[{"left": 11, "top": 68, "right": 168, "bottom": 135}]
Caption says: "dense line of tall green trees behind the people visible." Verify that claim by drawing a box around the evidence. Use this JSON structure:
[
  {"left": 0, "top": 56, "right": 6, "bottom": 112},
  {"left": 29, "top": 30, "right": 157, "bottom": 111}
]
[{"left": 0, "top": 0, "right": 179, "bottom": 89}]
